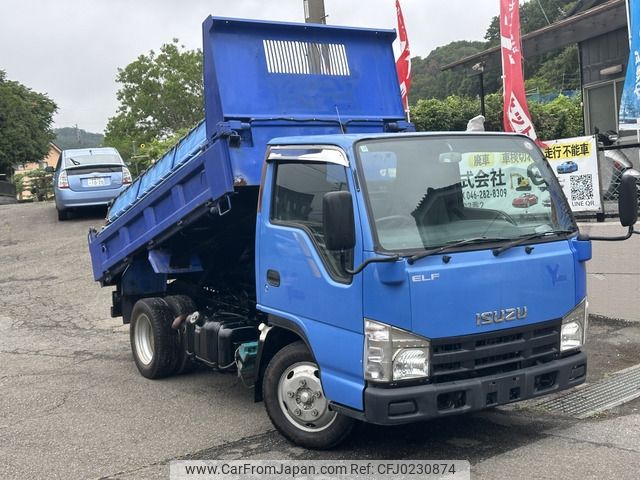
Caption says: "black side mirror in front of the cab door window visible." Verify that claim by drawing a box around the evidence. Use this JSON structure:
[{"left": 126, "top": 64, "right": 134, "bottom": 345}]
[{"left": 322, "top": 191, "right": 356, "bottom": 251}]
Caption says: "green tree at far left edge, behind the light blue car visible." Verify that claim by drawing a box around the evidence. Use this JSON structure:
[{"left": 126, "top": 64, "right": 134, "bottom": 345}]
[{"left": 0, "top": 70, "right": 58, "bottom": 174}]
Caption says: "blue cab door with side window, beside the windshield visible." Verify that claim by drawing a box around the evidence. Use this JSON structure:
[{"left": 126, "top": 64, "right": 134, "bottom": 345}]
[{"left": 256, "top": 146, "right": 364, "bottom": 408}]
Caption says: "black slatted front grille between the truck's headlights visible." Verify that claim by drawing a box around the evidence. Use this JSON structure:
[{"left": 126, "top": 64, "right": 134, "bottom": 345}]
[{"left": 431, "top": 320, "right": 561, "bottom": 383}]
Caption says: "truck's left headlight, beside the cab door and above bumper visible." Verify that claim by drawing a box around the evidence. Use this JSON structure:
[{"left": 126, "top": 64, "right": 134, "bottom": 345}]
[{"left": 364, "top": 319, "right": 430, "bottom": 382}]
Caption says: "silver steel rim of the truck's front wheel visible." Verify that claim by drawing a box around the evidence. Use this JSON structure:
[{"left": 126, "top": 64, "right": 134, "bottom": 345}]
[{"left": 278, "top": 362, "right": 337, "bottom": 432}]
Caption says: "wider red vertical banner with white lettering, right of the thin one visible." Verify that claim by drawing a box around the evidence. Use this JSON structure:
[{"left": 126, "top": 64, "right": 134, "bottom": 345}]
[{"left": 500, "top": 0, "right": 541, "bottom": 143}]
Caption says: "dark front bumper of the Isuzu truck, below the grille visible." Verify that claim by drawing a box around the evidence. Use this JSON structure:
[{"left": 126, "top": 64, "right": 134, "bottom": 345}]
[{"left": 360, "top": 352, "right": 587, "bottom": 425}]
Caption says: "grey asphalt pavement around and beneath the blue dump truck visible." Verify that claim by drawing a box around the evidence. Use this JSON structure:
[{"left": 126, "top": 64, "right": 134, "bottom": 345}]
[{"left": 0, "top": 203, "right": 640, "bottom": 480}]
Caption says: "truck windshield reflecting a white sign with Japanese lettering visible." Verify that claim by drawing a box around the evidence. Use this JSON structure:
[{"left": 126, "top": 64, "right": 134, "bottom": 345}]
[{"left": 356, "top": 134, "right": 577, "bottom": 252}]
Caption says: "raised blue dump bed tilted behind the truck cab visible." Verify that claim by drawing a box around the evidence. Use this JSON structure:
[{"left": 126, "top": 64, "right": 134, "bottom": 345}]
[{"left": 89, "top": 17, "right": 407, "bottom": 284}]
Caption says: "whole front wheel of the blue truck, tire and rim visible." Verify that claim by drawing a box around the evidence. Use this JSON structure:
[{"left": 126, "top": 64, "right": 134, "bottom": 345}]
[{"left": 262, "top": 342, "right": 354, "bottom": 450}]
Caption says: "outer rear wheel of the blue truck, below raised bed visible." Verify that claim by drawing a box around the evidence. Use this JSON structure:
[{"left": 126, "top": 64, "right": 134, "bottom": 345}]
[{"left": 129, "top": 298, "right": 177, "bottom": 379}]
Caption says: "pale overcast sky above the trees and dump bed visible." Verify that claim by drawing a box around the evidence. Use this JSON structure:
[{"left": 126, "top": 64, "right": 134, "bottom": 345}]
[{"left": 0, "top": 0, "right": 499, "bottom": 133}]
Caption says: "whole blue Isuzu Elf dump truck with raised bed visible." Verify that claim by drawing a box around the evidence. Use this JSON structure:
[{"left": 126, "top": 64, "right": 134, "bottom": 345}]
[{"left": 89, "top": 17, "right": 637, "bottom": 448}]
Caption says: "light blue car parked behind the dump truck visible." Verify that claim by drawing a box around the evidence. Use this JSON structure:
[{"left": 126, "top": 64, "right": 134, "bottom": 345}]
[{"left": 53, "top": 148, "right": 132, "bottom": 221}]
